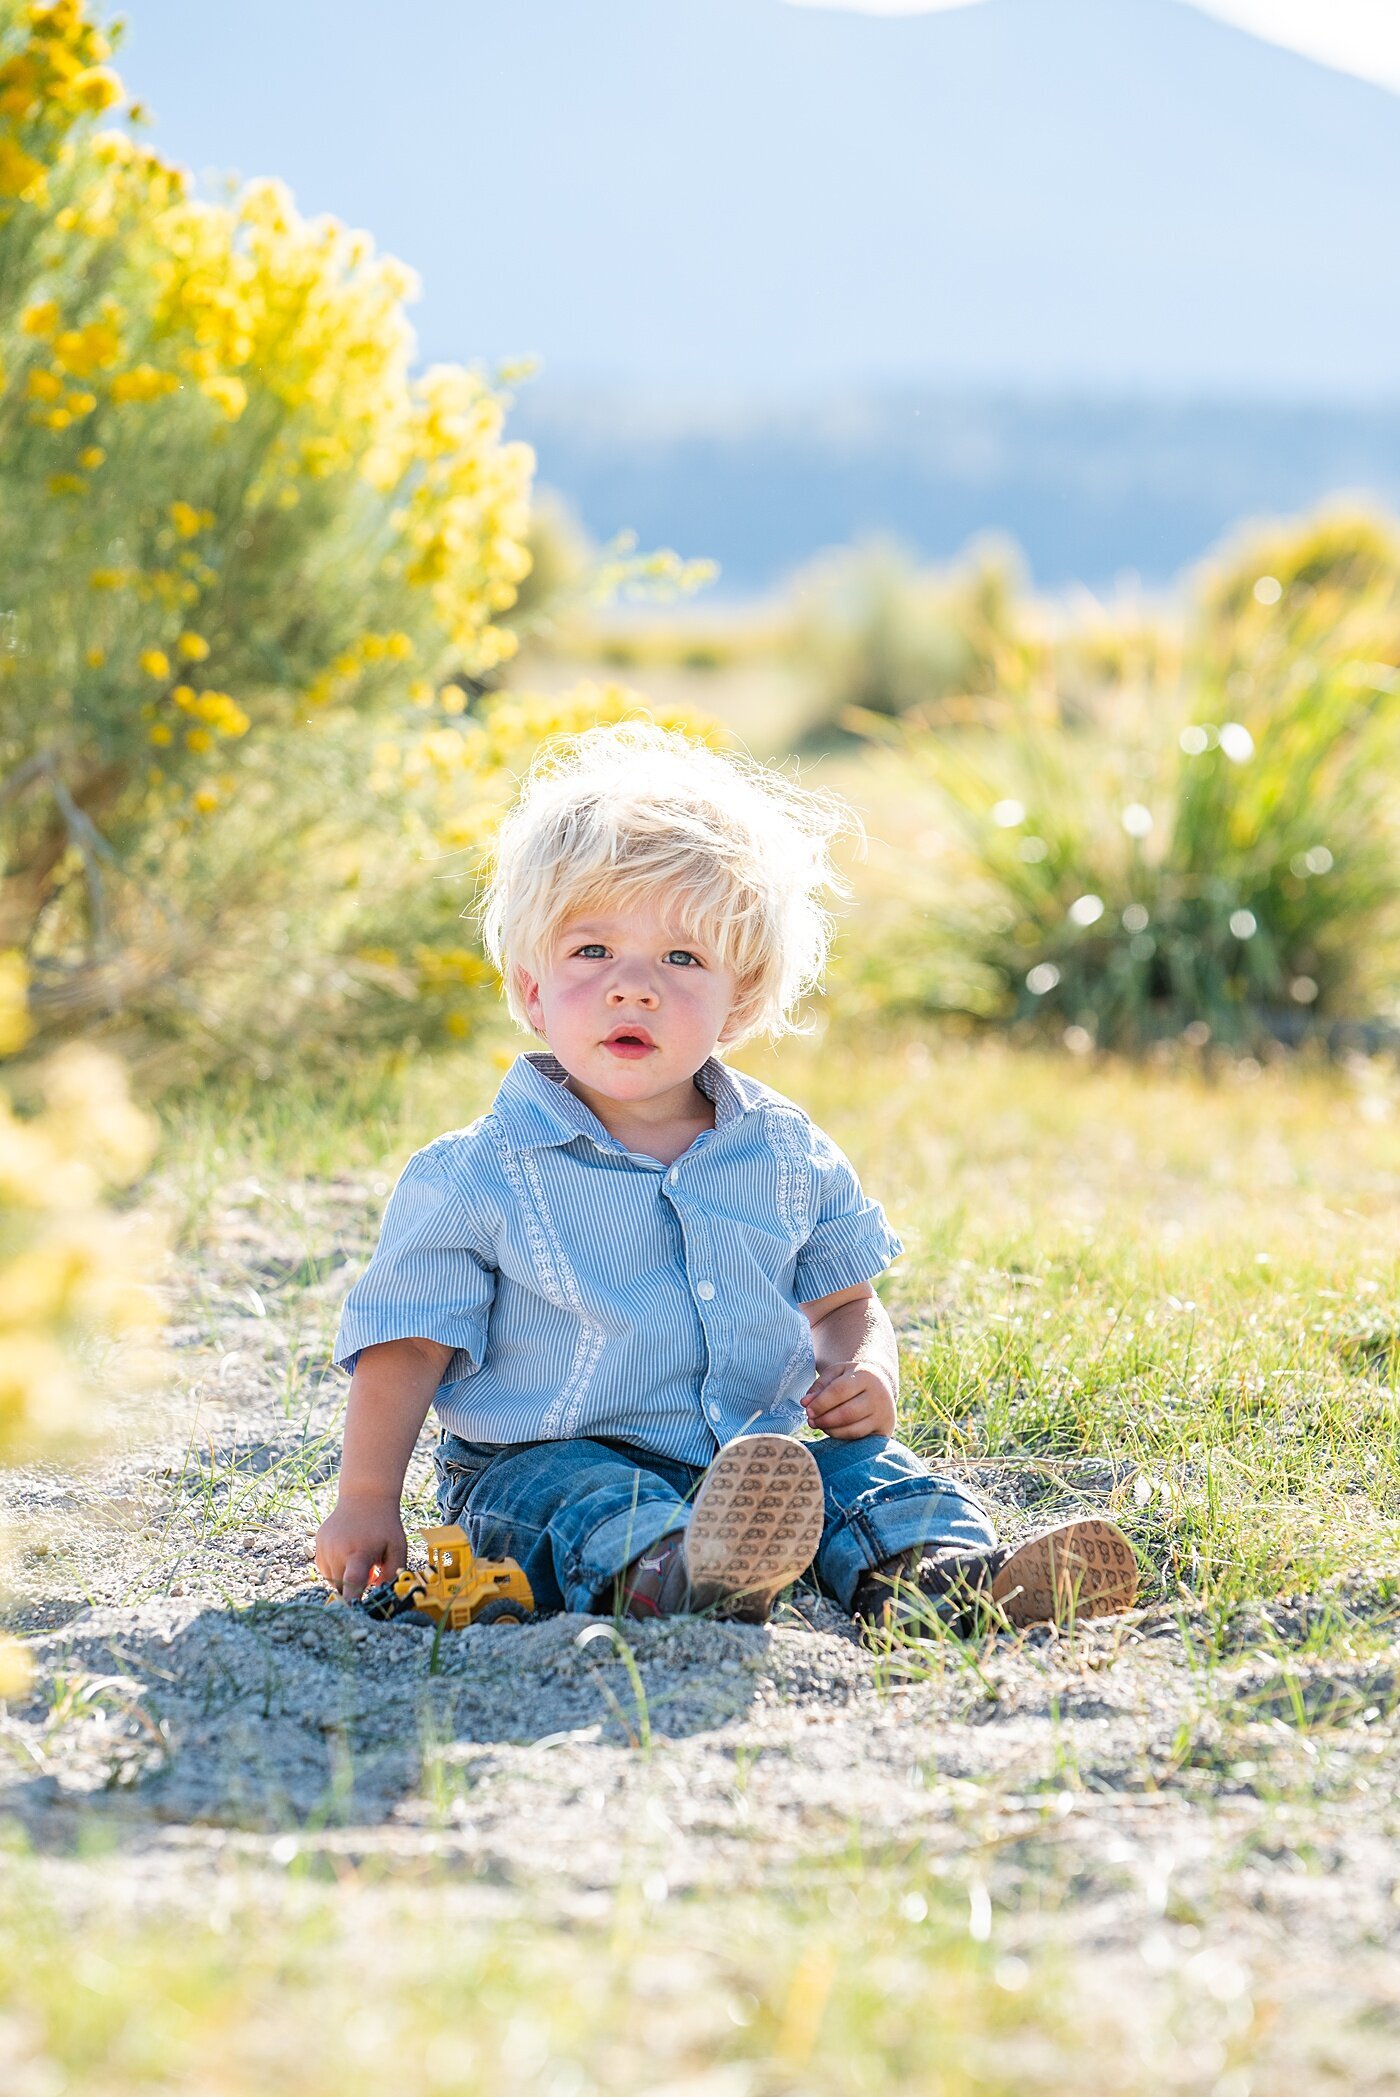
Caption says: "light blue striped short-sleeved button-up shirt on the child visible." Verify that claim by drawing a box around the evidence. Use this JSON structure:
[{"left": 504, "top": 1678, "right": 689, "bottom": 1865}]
[{"left": 335, "top": 1051, "right": 903, "bottom": 1464}]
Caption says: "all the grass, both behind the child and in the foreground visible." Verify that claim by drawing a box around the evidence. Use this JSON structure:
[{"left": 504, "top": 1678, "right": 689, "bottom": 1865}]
[{"left": 10, "top": 1025, "right": 1400, "bottom": 2097}]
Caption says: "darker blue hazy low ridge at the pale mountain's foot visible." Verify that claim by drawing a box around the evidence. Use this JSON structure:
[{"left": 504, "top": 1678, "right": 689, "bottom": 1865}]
[{"left": 511, "top": 390, "right": 1400, "bottom": 598}]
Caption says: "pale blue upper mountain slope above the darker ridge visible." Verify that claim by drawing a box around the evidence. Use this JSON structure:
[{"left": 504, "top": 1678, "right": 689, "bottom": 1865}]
[{"left": 122, "top": 0, "right": 1400, "bottom": 398}]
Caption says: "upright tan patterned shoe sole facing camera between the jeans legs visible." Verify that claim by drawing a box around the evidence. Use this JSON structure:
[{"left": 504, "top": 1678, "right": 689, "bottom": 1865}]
[{"left": 685, "top": 1434, "right": 826, "bottom": 1623}]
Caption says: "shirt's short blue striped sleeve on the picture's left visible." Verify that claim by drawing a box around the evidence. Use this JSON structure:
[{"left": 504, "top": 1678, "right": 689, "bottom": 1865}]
[{"left": 331, "top": 1147, "right": 497, "bottom": 1384}]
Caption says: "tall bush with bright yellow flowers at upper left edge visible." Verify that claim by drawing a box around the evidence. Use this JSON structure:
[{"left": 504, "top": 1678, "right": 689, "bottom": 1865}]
[{"left": 0, "top": 0, "right": 532, "bottom": 1025}]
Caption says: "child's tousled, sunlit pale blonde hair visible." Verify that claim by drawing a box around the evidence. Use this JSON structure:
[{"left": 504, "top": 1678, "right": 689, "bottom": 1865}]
[{"left": 480, "top": 721, "right": 863, "bottom": 1044}]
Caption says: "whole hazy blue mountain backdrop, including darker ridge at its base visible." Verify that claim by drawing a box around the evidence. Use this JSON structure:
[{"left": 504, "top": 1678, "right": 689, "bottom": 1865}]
[{"left": 119, "top": 0, "right": 1400, "bottom": 593}]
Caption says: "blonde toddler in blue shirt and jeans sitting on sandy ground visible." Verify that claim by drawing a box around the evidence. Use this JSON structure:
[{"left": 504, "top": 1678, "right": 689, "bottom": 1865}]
[{"left": 316, "top": 723, "right": 1136, "bottom": 1631}]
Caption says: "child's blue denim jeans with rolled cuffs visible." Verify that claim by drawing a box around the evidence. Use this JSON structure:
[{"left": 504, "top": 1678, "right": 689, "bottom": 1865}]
[{"left": 436, "top": 1434, "right": 996, "bottom": 1615}]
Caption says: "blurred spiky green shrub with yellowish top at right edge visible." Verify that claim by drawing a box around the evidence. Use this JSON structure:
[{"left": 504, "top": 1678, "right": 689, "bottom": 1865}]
[{"left": 842, "top": 514, "right": 1400, "bottom": 1049}]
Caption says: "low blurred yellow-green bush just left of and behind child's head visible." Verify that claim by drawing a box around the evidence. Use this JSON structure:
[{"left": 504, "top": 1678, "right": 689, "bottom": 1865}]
[{"left": 117, "top": 686, "right": 725, "bottom": 1065}]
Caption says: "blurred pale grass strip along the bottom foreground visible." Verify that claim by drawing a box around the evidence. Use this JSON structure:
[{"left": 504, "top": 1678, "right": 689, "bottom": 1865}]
[{"left": 0, "top": 1836, "right": 1270, "bottom": 2097}]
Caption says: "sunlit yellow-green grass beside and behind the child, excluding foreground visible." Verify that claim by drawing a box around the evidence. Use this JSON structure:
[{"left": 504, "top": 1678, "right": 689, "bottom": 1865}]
[{"left": 156, "top": 1032, "right": 1400, "bottom": 1608}]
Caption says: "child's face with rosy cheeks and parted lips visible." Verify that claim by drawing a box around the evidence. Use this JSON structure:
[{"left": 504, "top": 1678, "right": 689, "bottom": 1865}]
[{"left": 520, "top": 910, "right": 736, "bottom": 1101}]
